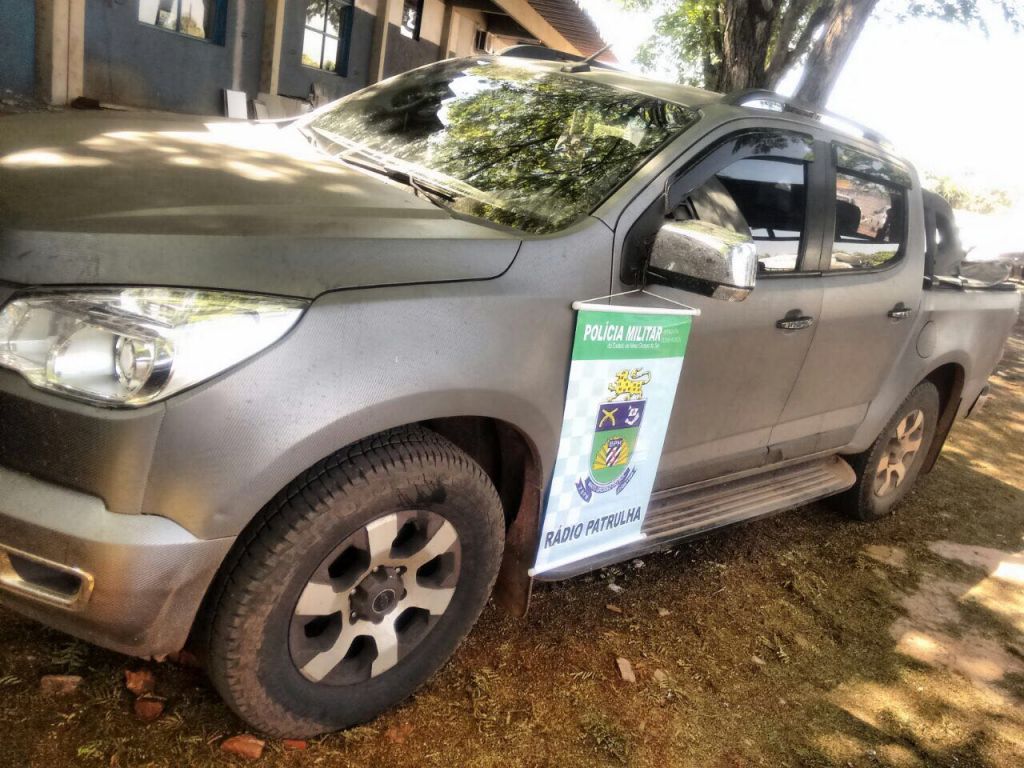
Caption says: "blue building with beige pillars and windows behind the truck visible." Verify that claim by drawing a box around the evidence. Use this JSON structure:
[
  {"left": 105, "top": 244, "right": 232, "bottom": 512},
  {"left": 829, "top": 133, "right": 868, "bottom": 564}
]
[{"left": 0, "top": 0, "right": 604, "bottom": 115}]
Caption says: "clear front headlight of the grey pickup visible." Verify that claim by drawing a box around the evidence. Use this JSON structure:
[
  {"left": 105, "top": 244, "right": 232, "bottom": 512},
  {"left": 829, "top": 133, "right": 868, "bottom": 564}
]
[{"left": 0, "top": 288, "right": 306, "bottom": 406}]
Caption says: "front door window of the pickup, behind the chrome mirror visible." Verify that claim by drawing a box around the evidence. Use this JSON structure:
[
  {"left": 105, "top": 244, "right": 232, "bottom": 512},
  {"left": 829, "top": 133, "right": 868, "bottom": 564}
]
[{"left": 689, "top": 158, "right": 807, "bottom": 272}]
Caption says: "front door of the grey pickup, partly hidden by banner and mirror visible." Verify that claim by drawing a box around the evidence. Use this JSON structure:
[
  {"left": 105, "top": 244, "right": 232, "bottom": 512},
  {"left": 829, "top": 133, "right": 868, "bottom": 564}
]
[{"left": 621, "top": 129, "right": 822, "bottom": 489}]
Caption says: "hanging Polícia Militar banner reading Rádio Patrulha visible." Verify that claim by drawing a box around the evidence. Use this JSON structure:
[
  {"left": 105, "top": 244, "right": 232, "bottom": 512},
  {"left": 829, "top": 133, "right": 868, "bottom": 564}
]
[{"left": 530, "top": 303, "right": 697, "bottom": 574}]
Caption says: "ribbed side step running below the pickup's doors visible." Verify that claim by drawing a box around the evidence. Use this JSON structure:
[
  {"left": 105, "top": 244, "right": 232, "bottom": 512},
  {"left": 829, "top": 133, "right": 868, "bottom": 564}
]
[{"left": 537, "top": 456, "right": 857, "bottom": 582}]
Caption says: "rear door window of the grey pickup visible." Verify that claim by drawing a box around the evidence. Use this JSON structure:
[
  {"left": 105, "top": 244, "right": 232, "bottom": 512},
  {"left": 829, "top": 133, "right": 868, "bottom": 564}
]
[{"left": 828, "top": 157, "right": 906, "bottom": 271}]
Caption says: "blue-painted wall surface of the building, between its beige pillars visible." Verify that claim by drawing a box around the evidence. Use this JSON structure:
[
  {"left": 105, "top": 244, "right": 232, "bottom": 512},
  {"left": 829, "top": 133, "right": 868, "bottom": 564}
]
[{"left": 0, "top": 0, "right": 448, "bottom": 115}]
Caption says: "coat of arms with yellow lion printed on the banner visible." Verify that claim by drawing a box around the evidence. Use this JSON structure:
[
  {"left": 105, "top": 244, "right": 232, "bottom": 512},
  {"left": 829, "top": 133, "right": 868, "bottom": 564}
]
[{"left": 577, "top": 369, "right": 650, "bottom": 502}]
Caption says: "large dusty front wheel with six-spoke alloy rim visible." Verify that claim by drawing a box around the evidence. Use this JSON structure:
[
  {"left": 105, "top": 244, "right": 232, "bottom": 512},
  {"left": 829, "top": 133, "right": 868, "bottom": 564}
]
[{"left": 204, "top": 428, "right": 505, "bottom": 737}]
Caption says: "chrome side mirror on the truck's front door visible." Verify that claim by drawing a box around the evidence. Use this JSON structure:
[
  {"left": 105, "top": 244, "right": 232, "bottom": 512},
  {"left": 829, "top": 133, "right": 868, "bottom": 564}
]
[{"left": 647, "top": 221, "right": 758, "bottom": 301}]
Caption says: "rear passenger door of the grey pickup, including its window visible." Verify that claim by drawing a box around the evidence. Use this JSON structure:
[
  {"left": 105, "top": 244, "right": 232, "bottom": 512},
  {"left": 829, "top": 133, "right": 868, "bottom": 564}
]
[{"left": 771, "top": 142, "right": 925, "bottom": 460}]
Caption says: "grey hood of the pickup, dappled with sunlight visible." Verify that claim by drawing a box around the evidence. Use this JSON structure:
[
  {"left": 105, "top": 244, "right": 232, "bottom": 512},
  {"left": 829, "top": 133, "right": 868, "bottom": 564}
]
[{"left": 0, "top": 112, "right": 520, "bottom": 297}]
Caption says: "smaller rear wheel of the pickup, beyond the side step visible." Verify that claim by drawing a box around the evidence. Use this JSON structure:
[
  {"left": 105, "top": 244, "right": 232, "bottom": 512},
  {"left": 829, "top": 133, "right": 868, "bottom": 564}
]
[{"left": 839, "top": 381, "right": 939, "bottom": 521}]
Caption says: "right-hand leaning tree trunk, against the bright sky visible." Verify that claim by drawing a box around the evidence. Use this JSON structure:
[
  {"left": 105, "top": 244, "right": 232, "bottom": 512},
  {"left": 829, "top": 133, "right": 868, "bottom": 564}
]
[{"left": 795, "top": 0, "right": 879, "bottom": 108}]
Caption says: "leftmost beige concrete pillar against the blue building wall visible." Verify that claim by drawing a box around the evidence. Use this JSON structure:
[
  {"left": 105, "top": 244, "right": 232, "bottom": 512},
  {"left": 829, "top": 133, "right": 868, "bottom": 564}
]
[{"left": 36, "top": 0, "right": 85, "bottom": 104}]
